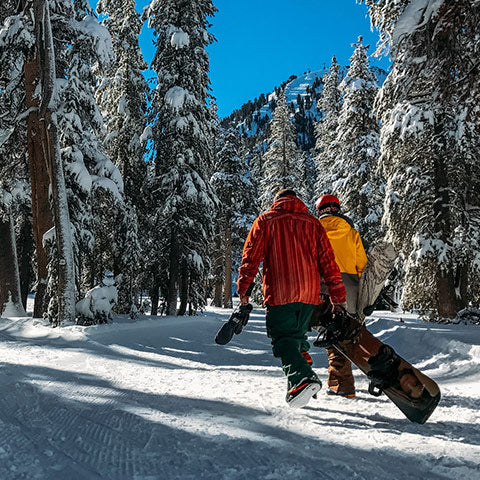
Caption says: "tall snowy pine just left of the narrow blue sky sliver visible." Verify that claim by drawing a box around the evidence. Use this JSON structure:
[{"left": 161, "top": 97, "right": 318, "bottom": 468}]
[{"left": 96, "top": 0, "right": 149, "bottom": 313}]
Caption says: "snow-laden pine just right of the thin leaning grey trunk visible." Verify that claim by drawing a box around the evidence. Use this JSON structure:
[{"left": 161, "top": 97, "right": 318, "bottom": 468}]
[{"left": 52, "top": 0, "right": 123, "bottom": 296}]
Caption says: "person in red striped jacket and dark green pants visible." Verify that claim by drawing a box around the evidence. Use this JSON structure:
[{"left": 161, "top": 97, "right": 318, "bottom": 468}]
[{"left": 237, "top": 189, "right": 346, "bottom": 407}]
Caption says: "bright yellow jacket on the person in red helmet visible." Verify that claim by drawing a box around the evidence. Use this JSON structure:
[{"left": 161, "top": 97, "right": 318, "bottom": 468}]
[{"left": 320, "top": 215, "right": 367, "bottom": 277}]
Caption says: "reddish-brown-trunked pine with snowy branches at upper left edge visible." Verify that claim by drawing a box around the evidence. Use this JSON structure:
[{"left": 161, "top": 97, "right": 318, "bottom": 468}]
[{"left": 0, "top": 0, "right": 53, "bottom": 317}]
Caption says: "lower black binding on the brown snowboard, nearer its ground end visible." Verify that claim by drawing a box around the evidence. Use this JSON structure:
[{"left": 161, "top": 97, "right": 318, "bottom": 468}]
[{"left": 367, "top": 345, "right": 400, "bottom": 397}]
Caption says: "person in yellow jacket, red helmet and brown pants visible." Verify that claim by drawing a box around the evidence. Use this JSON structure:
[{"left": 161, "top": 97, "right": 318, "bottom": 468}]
[{"left": 315, "top": 195, "right": 367, "bottom": 398}]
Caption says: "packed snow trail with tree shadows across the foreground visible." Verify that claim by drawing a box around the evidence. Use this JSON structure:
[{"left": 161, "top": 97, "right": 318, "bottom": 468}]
[{"left": 0, "top": 309, "right": 480, "bottom": 480}]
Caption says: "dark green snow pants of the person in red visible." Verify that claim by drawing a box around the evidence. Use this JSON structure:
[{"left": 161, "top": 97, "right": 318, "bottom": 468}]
[{"left": 266, "top": 302, "right": 315, "bottom": 389}]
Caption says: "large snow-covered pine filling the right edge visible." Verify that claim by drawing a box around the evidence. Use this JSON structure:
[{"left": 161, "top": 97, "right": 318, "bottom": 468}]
[{"left": 364, "top": 0, "right": 480, "bottom": 318}]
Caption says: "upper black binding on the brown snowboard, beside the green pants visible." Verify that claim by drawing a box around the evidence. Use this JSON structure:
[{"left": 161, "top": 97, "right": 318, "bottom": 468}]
[{"left": 313, "top": 302, "right": 362, "bottom": 348}]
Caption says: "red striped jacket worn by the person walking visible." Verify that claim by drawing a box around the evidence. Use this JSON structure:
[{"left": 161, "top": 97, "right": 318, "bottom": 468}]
[{"left": 237, "top": 195, "right": 346, "bottom": 306}]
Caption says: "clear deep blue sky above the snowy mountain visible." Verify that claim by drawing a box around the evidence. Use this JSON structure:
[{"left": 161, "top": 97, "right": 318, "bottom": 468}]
[{"left": 90, "top": 0, "right": 388, "bottom": 117}]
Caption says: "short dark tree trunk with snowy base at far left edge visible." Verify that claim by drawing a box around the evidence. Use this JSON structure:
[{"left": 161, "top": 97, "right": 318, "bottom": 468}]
[{"left": 0, "top": 214, "right": 25, "bottom": 316}]
